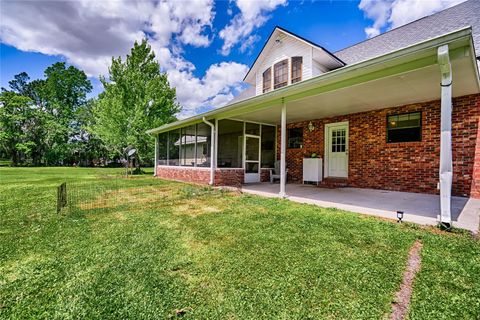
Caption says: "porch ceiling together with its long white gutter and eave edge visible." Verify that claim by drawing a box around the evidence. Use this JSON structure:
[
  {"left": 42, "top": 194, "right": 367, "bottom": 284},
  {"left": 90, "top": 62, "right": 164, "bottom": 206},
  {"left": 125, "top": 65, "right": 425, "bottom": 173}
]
[{"left": 147, "top": 28, "right": 480, "bottom": 134}]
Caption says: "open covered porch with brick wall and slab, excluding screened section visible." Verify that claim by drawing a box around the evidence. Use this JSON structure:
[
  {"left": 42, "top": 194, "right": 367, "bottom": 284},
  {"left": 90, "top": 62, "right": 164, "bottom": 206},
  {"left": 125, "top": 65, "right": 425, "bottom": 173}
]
[{"left": 218, "top": 26, "right": 479, "bottom": 232}]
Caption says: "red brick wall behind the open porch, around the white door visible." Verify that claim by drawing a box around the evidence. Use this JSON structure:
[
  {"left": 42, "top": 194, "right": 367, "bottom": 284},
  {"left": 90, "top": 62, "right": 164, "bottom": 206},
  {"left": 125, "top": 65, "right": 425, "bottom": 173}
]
[{"left": 277, "top": 95, "right": 480, "bottom": 197}]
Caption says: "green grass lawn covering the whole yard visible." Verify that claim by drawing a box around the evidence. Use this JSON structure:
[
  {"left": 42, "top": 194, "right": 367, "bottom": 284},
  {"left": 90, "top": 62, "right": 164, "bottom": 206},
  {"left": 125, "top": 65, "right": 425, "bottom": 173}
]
[{"left": 0, "top": 168, "right": 480, "bottom": 319}]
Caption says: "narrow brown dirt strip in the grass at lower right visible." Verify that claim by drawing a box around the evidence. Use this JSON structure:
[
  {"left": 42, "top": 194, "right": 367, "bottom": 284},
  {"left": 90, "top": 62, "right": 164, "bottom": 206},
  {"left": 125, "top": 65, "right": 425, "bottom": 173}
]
[{"left": 390, "top": 240, "right": 422, "bottom": 320}]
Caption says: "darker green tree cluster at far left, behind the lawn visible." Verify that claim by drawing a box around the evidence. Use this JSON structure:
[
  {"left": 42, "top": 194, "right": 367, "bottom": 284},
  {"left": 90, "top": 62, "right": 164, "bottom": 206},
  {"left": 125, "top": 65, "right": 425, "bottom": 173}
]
[{"left": 0, "top": 62, "right": 92, "bottom": 165}]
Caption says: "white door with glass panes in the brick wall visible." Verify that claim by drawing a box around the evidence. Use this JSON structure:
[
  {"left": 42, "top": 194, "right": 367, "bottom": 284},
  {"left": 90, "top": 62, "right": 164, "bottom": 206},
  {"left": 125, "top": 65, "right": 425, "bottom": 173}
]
[{"left": 325, "top": 122, "right": 348, "bottom": 178}]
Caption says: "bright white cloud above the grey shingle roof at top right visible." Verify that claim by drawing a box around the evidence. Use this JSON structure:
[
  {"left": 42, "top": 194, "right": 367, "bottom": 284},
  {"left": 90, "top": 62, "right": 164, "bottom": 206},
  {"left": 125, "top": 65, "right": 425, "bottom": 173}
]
[{"left": 358, "top": 0, "right": 465, "bottom": 38}]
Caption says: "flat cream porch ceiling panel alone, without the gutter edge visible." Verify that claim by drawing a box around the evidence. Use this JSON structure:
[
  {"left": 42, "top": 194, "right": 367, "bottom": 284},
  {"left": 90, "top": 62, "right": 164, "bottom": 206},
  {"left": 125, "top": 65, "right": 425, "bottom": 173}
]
[{"left": 236, "top": 56, "right": 479, "bottom": 124}]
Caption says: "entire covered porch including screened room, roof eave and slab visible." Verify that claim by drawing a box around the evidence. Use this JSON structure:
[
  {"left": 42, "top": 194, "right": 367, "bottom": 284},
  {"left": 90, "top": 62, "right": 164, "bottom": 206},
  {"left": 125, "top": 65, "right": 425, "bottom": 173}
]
[{"left": 149, "top": 29, "right": 480, "bottom": 230}]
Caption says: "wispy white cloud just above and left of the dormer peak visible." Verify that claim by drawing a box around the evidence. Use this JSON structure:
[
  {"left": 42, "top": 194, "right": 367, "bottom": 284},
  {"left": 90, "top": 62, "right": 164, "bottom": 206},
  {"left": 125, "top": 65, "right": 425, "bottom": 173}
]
[{"left": 219, "top": 0, "right": 287, "bottom": 55}]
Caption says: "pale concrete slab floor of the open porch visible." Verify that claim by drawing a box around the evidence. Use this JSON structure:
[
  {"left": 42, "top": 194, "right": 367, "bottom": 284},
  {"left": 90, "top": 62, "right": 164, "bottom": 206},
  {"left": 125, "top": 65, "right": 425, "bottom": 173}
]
[{"left": 241, "top": 183, "right": 480, "bottom": 233}]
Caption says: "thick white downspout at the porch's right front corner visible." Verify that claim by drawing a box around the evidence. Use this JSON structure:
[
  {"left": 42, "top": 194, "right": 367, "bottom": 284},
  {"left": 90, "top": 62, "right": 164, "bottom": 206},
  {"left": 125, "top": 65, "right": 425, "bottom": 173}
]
[{"left": 437, "top": 45, "right": 453, "bottom": 229}]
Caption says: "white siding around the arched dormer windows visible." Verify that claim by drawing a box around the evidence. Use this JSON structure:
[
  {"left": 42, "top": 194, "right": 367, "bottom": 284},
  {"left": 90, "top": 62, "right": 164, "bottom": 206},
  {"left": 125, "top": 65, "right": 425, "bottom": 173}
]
[{"left": 256, "top": 35, "right": 312, "bottom": 95}]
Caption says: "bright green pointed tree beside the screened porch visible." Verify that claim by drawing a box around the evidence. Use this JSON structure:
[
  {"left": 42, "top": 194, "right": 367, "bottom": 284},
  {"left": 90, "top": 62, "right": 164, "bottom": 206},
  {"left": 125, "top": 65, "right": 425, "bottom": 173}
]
[{"left": 92, "top": 40, "right": 180, "bottom": 161}]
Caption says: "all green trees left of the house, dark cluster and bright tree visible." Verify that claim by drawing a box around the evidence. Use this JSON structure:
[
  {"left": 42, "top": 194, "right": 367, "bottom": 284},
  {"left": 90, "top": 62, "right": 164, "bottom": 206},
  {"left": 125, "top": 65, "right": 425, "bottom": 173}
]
[{"left": 0, "top": 40, "right": 180, "bottom": 166}]
